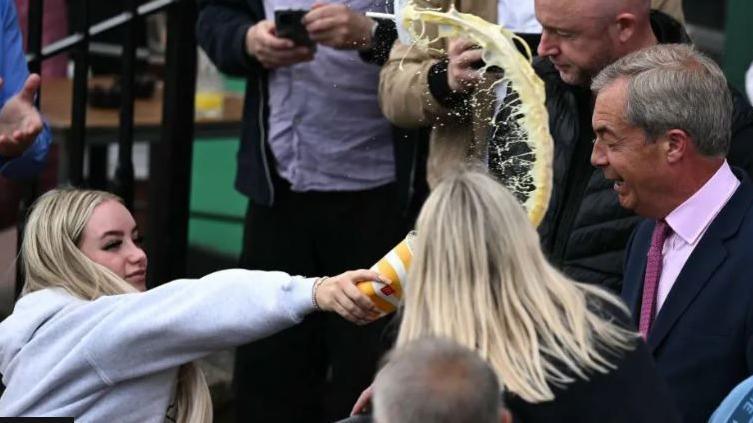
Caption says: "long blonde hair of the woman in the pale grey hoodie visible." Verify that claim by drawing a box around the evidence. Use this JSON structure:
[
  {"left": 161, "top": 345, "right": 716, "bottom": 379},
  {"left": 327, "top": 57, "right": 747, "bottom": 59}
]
[{"left": 21, "top": 189, "right": 212, "bottom": 423}]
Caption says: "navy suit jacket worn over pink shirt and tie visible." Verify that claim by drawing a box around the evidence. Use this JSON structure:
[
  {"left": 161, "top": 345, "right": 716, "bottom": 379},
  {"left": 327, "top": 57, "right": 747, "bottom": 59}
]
[{"left": 622, "top": 169, "right": 753, "bottom": 422}]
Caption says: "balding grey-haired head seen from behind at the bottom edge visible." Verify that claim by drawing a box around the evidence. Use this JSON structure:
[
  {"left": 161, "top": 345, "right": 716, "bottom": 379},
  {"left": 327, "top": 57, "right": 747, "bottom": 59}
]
[{"left": 373, "top": 338, "right": 502, "bottom": 423}]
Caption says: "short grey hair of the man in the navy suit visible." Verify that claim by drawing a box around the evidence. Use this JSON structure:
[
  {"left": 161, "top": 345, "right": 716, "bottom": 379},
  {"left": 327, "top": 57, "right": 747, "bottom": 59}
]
[{"left": 591, "top": 44, "right": 732, "bottom": 157}]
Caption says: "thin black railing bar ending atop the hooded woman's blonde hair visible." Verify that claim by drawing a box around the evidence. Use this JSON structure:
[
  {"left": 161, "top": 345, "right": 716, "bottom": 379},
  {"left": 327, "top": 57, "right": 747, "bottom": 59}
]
[{"left": 66, "top": 0, "right": 89, "bottom": 186}]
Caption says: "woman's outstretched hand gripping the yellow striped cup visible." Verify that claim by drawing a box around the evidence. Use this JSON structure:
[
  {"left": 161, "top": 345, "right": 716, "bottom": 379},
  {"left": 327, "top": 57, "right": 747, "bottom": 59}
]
[{"left": 315, "top": 270, "right": 386, "bottom": 325}]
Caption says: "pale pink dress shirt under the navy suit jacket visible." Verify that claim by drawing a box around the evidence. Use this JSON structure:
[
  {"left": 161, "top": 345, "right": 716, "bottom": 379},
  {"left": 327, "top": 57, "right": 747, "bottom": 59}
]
[{"left": 656, "top": 160, "right": 740, "bottom": 315}]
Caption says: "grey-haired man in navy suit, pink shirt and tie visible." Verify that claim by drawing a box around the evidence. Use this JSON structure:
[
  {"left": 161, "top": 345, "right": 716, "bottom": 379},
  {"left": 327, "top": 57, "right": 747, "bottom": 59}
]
[{"left": 591, "top": 45, "right": 753, "bottom": 422}]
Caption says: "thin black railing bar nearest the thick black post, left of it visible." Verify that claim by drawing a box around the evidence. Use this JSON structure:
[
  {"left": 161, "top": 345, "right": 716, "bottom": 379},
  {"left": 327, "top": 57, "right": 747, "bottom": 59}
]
[{"left": 113, "top": 0, "right": 138, "bottom": 210}]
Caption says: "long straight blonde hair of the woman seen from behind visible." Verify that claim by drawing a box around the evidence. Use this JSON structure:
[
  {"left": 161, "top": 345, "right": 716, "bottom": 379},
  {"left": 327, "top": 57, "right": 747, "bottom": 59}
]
[{"left": 397, "top": 171, "right": 636, "bottom": 402}]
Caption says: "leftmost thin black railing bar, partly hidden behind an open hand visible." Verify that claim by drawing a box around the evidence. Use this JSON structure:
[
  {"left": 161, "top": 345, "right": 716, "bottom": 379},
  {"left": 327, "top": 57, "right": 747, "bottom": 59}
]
[{"left": 15, "top": 0, "right": 44, "bottom": 298}]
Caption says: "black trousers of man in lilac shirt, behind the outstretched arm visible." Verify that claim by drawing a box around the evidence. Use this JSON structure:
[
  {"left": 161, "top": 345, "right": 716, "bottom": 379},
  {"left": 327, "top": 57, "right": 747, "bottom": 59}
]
[{"left": 234, "top": 181, "right": 405, "bottom": 423}]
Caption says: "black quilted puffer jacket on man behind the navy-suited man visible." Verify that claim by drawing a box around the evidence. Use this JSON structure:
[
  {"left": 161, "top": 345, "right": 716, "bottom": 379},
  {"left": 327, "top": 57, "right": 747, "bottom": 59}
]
[{"left": 534, "top": 12, "right": 753, "bottom": 292}]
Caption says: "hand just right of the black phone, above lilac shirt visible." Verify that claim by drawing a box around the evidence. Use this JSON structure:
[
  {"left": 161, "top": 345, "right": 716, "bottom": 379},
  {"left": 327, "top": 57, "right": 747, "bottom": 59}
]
[{"left": 303, "top": 2, "right": 374, "bottom": 50}]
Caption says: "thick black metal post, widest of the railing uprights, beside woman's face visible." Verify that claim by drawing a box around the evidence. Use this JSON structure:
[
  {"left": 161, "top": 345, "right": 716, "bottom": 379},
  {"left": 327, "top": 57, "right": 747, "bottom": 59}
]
[{"left": 147, "top": 0, "right": 197, "bottom": 287}]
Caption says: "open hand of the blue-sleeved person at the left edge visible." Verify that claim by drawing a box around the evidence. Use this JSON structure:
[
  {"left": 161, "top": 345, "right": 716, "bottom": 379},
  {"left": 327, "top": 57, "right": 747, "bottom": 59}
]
[{"left": 0, "top": 74, "right": 43, "bottom": 158}]
